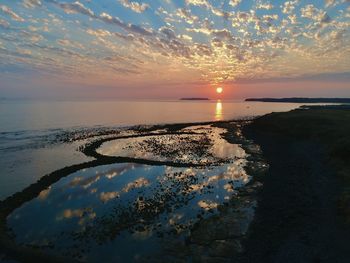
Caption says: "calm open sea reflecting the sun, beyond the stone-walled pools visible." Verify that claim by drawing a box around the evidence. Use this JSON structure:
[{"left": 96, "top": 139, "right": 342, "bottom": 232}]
[{"left": 0, "top": 100, "right": 308, "bottom": 199}]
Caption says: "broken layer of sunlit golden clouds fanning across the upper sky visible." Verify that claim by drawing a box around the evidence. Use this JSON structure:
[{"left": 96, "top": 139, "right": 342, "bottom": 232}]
[{"left": 0, "top": 0, "right": 350, "bottom": 91}]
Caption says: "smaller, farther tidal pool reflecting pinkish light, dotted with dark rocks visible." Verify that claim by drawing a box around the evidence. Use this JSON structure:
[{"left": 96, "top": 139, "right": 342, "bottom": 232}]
[{"left": 97, "top": 125, "right": 245, "bottom": 164}]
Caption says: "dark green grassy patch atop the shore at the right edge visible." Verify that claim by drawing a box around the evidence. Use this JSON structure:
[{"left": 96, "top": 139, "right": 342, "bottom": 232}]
[{"left": 249, "top": 106, "right": 350, "bottom": 223}]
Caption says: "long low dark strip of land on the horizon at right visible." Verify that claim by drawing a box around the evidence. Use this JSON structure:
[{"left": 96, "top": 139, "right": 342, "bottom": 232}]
[{"left": 245, "top": 98, "right": 350, "bottom": 103}]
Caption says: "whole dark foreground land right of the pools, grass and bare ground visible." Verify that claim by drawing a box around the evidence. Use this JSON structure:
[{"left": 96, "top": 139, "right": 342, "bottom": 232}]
[{"left": 240, "top": 106, "right": 350, "bottom": 262}]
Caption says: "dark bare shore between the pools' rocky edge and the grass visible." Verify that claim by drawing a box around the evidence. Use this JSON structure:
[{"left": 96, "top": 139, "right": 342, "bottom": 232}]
[{"left": 241, "top": 127, "right": 350, "bottom": 263}]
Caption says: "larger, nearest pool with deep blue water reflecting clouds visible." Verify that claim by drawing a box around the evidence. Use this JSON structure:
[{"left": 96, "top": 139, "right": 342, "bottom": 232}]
[{"left": 8, "top": 162, "right": 249, "bottom": 262}]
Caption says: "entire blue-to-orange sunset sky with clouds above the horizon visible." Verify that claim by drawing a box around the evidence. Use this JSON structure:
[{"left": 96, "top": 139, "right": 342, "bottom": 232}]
[{"left": 0, "top": 0, "right": 350, "bottom": 99}]
